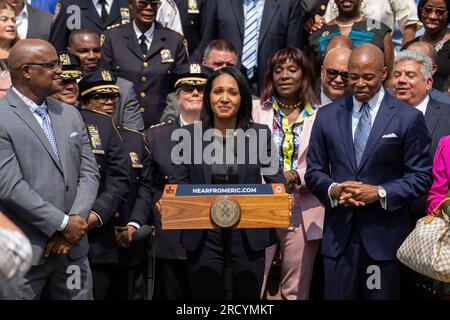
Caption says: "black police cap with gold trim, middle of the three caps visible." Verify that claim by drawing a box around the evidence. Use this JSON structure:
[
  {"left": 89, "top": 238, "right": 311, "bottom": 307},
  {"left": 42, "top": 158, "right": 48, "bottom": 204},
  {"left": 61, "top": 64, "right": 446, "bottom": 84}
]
[{"left": 78, "top": 69, "right": 119, "bottom": 97}]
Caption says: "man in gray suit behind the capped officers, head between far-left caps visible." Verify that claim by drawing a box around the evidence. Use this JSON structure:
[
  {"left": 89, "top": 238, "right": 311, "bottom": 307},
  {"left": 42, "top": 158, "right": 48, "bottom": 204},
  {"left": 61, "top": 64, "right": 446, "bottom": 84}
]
[{"left": 68, "top": 29, "right": 144, "bottom": 131}]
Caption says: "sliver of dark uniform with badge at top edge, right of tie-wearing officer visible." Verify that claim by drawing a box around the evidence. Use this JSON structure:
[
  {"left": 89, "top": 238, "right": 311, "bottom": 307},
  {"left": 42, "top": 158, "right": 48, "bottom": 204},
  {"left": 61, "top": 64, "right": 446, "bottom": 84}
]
[{"left": 174, "top": 0, "right": 205, "bottom": 54}]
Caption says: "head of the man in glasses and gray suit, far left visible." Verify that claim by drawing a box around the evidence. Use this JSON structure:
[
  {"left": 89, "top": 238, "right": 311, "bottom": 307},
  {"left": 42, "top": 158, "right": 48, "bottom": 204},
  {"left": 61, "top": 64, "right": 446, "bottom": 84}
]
[{"left": 8, "top": 39, "right": 62, "bottom": 105}]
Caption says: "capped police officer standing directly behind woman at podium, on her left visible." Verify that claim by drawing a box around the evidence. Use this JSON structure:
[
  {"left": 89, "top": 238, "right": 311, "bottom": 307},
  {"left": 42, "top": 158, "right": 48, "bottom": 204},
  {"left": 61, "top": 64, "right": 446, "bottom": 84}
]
[{"left": 145, "top": 64, "right": 210, "bottom": 300}]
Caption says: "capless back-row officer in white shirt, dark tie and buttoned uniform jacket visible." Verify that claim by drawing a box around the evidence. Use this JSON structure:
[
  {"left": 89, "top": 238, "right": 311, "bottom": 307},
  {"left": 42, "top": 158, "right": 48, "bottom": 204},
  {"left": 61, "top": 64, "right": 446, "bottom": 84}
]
[{"left": 102, "top": 0, "right": 187, "bottom": 128}]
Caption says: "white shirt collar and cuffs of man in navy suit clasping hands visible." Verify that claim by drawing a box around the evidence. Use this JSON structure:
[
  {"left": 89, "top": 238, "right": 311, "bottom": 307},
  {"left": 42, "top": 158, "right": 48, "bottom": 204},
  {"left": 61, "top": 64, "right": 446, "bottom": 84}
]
[{"left": 328, "top": 87, "right": 387, "bottom": 210}]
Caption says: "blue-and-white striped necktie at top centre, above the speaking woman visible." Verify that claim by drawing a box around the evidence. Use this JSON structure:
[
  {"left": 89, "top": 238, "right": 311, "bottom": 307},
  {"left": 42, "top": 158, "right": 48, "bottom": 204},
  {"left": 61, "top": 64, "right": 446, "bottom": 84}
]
[{"left": 242, "top": 0, "right": 258, "bottom": 79}]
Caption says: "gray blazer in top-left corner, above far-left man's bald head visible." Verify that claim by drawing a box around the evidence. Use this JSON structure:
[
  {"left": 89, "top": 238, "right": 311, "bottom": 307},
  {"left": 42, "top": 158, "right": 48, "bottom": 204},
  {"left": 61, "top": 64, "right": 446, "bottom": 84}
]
[{"left": 26, "top": 3, "right": 53, "bottom": 41}]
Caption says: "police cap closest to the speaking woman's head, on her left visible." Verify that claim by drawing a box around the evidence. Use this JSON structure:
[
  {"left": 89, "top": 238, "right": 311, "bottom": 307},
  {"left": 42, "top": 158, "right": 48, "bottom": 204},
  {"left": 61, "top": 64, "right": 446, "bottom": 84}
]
[{"left": 173, "top": 63, "right": 212, "bottom": 90}]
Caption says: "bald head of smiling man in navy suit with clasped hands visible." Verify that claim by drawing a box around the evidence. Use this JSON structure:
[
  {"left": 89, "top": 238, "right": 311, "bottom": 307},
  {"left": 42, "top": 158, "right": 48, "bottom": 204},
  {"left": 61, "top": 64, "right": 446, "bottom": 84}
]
[{"left": 348, "top": 43, "right": 387, "bottom": 102}]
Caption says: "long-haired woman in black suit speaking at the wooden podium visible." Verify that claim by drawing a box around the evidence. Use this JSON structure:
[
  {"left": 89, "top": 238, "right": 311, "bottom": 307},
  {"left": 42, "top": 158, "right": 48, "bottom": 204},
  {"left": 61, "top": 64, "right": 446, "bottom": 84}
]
[{"left": 170, "top": 67, "right": 285, "bottom": 300}]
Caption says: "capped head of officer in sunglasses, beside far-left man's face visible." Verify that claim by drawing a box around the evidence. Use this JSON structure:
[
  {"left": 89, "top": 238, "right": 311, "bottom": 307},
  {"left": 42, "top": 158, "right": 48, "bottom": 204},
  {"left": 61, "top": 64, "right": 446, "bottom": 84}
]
[{"left": 53, "top": 51, "right": 81, "bottom": 106}]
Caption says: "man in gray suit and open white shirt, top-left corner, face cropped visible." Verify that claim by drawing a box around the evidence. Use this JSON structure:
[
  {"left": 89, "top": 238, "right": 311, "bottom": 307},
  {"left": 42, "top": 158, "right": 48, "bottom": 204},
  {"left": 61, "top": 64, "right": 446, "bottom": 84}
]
[{"left": 6, "top": 0, "right": 53, "bottom": 40}]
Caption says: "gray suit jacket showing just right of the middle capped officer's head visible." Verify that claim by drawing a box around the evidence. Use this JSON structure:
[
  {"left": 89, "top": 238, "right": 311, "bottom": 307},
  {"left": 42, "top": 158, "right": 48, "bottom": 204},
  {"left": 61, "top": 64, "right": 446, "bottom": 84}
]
[{"left": 113, "top": 77, "right": 144, "bottom": 131}]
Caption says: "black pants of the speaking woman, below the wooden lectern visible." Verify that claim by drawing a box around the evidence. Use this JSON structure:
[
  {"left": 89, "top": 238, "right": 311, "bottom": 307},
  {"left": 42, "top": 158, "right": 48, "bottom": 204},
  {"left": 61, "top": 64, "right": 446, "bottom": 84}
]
[{"left": 187, "top": 230, "right": 265, "bottom": 300}]
